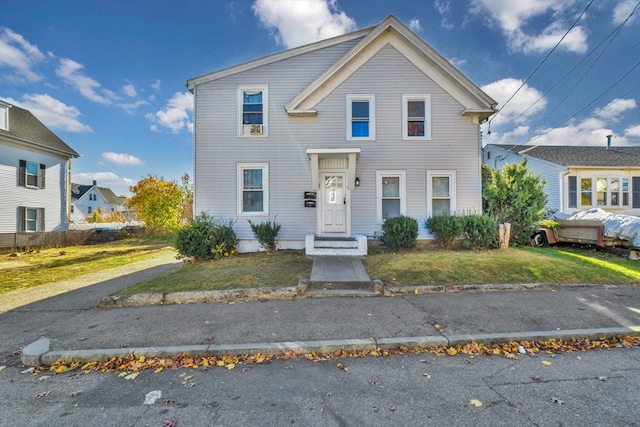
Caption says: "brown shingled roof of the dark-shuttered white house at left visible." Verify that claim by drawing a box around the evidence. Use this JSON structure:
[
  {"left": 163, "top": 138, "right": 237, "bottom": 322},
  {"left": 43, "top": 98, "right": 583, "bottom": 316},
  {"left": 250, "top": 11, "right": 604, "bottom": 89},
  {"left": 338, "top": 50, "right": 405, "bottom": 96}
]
[{"left": 0, "top": 102, "right": 80, "bottom": 157}]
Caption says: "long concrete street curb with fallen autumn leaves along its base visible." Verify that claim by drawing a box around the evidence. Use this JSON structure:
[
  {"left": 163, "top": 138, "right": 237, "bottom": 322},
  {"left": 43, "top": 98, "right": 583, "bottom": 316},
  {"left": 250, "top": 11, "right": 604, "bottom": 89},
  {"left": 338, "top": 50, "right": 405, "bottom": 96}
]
[{"left": 20, "top": 326, "right": 640, "bottom": 366}]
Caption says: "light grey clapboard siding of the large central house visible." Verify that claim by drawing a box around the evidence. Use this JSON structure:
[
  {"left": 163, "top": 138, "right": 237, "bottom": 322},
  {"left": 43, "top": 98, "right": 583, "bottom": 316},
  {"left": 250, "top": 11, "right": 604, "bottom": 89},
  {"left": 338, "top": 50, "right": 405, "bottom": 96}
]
[{"left": 194, "top": 41, "right": 481, "bottom": 251}]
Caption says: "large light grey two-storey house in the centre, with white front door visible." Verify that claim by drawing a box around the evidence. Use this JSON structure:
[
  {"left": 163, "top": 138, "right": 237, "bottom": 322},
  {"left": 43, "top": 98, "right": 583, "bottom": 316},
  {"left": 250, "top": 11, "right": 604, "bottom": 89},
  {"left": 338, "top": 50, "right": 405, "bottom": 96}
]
[{"left": 187, "top": 16, "right": 496, "bottom": 254}]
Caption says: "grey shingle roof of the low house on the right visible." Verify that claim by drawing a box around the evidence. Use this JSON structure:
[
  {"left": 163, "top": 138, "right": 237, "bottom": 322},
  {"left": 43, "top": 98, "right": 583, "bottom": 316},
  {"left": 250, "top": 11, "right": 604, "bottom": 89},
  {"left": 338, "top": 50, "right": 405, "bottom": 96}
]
[{"left": 485, "top": 144, "right": 640, "bottom": 168}]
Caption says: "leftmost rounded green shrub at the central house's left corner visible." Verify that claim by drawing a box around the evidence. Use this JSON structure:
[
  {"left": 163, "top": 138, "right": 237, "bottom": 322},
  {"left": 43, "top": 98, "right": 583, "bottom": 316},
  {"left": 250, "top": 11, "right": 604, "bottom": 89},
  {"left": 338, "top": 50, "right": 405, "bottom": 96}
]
[{"left": 174, "top": 212, "right": 237, "bottom": 261}]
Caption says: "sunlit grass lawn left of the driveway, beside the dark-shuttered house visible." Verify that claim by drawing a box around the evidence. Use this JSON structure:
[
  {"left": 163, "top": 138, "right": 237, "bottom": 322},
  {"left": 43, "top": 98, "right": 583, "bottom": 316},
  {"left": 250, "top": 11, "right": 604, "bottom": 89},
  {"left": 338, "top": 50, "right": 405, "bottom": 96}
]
[{"left": 0, "top": 237, "right": 168, "bottom": 295}]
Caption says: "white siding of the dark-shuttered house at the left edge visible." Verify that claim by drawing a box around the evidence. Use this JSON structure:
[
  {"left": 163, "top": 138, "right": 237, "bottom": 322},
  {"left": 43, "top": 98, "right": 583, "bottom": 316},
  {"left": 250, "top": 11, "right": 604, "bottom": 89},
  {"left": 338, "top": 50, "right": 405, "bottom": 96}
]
[{"left": 0, "top": 141, "right": 68, "bottom": 233}]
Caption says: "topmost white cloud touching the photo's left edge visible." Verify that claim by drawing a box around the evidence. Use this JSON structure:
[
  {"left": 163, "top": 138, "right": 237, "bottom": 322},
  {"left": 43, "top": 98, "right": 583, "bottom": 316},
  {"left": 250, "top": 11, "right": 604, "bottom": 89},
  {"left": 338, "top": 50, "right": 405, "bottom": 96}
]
[{"left": 0, "top": 27, "right": 45, "bottom": 83}]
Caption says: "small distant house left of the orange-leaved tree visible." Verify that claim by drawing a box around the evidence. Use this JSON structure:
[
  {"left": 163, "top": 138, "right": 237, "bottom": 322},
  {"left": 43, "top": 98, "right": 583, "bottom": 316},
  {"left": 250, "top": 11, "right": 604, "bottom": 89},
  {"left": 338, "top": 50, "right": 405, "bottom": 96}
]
[{"left": 71, "top": 180, "right": 128, "bottom": 223}]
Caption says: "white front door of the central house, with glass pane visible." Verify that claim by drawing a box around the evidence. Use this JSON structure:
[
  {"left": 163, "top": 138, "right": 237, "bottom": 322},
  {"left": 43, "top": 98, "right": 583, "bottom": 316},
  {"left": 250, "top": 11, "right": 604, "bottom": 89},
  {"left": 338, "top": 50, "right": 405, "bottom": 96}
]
[{"left": 320, "top": 172, "right": 347, "bottom": 233}]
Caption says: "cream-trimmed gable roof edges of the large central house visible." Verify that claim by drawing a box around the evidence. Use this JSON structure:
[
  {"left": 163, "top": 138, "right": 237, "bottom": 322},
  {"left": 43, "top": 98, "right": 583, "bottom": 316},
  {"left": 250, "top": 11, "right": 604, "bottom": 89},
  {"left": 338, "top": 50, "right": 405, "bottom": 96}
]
[{"left": 187, "top": 15, "right": 497, "bottom": 122}]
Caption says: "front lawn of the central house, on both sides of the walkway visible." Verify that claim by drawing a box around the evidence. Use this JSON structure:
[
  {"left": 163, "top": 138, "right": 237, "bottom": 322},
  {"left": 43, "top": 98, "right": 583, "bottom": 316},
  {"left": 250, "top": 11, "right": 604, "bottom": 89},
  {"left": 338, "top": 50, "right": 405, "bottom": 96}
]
[{"left": 118, "top": 242, "right": 640, "bottom": 295}]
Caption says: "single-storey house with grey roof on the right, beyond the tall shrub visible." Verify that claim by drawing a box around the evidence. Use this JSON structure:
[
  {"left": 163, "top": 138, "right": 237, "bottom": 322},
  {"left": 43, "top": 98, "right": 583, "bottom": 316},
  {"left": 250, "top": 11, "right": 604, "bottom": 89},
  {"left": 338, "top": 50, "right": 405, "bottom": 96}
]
[{"left": 483, "top": 144, "right": 640, "bottom": 216}]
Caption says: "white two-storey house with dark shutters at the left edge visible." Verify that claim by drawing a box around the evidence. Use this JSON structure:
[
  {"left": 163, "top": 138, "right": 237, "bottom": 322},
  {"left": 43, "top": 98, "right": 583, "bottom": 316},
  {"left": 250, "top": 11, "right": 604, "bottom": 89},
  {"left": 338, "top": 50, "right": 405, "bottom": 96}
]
[{"left": 0, "top": 101, "right": 79, "bottom": 233}]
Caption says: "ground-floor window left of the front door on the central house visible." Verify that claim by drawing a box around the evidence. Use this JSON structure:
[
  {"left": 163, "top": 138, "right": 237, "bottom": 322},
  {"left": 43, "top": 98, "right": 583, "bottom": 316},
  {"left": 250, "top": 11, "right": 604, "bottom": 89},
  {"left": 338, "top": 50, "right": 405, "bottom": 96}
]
[{"left": 237, "top": 163, "right": 269, "bottom": 215}]
